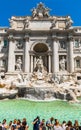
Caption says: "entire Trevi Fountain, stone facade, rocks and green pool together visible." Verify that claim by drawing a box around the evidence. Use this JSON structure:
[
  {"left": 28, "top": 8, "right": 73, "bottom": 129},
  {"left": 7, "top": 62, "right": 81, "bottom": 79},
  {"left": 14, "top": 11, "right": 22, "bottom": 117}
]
[{"left": 0, "top": 2, "right": 81, "bottom": 127}]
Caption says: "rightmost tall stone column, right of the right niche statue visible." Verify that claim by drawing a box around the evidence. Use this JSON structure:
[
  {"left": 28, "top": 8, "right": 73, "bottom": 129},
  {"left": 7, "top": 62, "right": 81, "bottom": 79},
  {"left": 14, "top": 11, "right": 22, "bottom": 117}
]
[{"left": 68, "top": 38, "right": 74, "bottom": 73}]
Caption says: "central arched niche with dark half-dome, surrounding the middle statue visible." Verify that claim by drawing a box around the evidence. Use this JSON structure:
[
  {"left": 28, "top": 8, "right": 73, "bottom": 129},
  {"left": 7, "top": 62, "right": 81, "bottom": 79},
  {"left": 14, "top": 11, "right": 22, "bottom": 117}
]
[{"left": 30, "top": 42, "right": 51, "bottom": 72}]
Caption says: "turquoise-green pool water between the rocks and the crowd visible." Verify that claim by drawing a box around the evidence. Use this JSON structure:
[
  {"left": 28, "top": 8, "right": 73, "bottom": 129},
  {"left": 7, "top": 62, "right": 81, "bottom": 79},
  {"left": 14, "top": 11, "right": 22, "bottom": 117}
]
[{"left": 0, "top": 99, "right": 81, "bottom": 130}]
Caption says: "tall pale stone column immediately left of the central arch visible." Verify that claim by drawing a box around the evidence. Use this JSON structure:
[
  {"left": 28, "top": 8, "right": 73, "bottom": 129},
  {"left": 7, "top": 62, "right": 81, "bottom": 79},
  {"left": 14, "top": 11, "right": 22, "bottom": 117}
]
[{"left": 24, "top": 35, "right": 30, "bottom": 73}]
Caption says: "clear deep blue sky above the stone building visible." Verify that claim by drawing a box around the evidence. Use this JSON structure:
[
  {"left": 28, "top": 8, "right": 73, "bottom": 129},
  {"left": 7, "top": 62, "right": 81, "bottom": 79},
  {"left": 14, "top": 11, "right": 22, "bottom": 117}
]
[{"left": 0, "top": 0, "right": 81, "bottom": 27}]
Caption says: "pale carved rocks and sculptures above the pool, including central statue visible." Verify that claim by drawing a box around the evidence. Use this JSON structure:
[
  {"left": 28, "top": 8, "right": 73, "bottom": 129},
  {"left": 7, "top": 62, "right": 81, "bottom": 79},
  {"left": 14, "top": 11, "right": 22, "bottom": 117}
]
[{"left": 0, "top": 57, "right": 81, "bottom": 102}]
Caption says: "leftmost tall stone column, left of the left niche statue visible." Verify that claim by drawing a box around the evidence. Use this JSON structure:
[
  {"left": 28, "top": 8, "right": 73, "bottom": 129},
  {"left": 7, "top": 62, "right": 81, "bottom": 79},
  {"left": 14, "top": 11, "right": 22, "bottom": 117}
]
[{"left": 8, "top": 35, "right": 15, "bottom": 72}]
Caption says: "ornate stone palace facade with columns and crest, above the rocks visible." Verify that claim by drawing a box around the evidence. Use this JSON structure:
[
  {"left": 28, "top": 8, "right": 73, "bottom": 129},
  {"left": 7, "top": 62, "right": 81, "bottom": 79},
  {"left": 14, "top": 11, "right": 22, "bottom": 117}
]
[{"left": 0, "top": 2, "right": 81, "bottom": 75}]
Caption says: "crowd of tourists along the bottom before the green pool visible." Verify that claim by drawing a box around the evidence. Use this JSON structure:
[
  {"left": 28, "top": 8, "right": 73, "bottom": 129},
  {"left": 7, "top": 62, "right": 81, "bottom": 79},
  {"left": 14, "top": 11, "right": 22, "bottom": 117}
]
[{"left": 0, "top": 116, "right": 81, "bottom": 130}]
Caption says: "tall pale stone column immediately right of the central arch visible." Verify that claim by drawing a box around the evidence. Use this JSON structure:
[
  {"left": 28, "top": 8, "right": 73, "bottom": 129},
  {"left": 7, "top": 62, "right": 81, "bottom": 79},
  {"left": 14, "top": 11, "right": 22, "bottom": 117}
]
[{"left": 52, "top": 38, "right": 59, "bottom": 73}]
